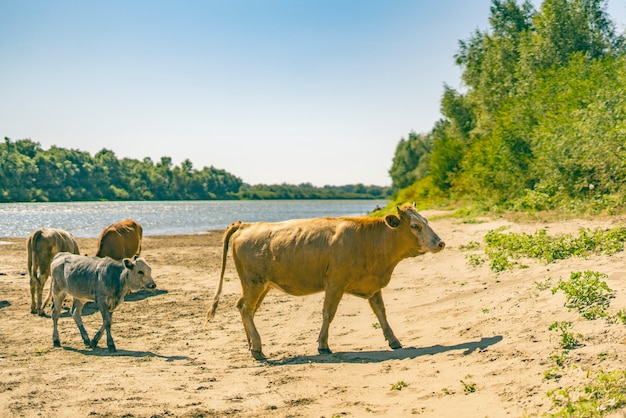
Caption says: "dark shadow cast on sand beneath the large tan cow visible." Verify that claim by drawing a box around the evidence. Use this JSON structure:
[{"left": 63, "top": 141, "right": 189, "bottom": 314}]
[{"left": 267, "top": 335, "right": 502, "bottom": 366}]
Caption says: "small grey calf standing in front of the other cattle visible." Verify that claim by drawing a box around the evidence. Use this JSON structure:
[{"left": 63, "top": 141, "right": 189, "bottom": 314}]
[{"left": 50, "top": 253, "right": 156, "bottom": 353}]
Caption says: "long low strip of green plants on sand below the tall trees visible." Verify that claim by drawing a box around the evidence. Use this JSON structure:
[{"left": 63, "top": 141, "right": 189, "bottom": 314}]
[{"left": 485, "top": 227, "right": 626, "bottom": 271}]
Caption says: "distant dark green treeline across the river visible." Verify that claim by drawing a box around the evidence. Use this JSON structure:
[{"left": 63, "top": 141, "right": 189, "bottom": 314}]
[{"left": 0, "top": 138, "right": 391, "bottom": 203}]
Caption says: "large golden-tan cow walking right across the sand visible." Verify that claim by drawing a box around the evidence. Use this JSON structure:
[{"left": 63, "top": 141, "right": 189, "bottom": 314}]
[{"left": 205, "top": 204, "right": 445, "bottom": 361}]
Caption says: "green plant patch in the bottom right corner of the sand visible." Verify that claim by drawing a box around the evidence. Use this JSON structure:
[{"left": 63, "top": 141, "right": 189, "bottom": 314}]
[{"left": 548, "top": 370, "right": 626, "bottom": 418}]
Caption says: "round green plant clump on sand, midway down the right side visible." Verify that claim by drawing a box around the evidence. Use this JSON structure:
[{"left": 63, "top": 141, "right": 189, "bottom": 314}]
[{"left": 552, "top": 271, "right": 613, "bottom": 319}]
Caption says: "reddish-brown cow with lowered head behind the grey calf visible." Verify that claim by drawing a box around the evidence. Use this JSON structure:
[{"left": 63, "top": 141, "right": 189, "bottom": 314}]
[{"left": 96, "top": 219, "right": 143, "bottom": 260}]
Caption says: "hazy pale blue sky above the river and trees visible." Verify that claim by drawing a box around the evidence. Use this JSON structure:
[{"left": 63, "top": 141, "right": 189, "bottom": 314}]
[{"left": 0, "top": 0, "right": 626, "bottom": 186}]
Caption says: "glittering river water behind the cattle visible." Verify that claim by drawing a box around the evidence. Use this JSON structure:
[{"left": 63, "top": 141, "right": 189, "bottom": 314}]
[{"left": 0, "top": 200, "right": 387, "bottom": 238}]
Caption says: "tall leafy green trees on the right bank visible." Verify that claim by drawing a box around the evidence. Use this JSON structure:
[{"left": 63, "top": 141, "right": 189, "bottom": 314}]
[{"left": 389, "top": 0, "right": 626, "bottom": 212}]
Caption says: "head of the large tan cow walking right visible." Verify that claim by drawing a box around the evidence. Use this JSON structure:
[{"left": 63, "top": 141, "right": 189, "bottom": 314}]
[{"left": 385, "top": 204, "right": 446, "bottom": 256}]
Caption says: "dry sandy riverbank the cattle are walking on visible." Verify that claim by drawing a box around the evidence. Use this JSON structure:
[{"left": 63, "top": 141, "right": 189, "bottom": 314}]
[{"left": 0, "top": 212, "right": 626, "bottom": 418}]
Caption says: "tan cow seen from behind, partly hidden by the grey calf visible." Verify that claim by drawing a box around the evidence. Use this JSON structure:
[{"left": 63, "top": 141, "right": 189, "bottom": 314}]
[{"left": 26, "top": 228, "right": 79, "bottom": 315}]
